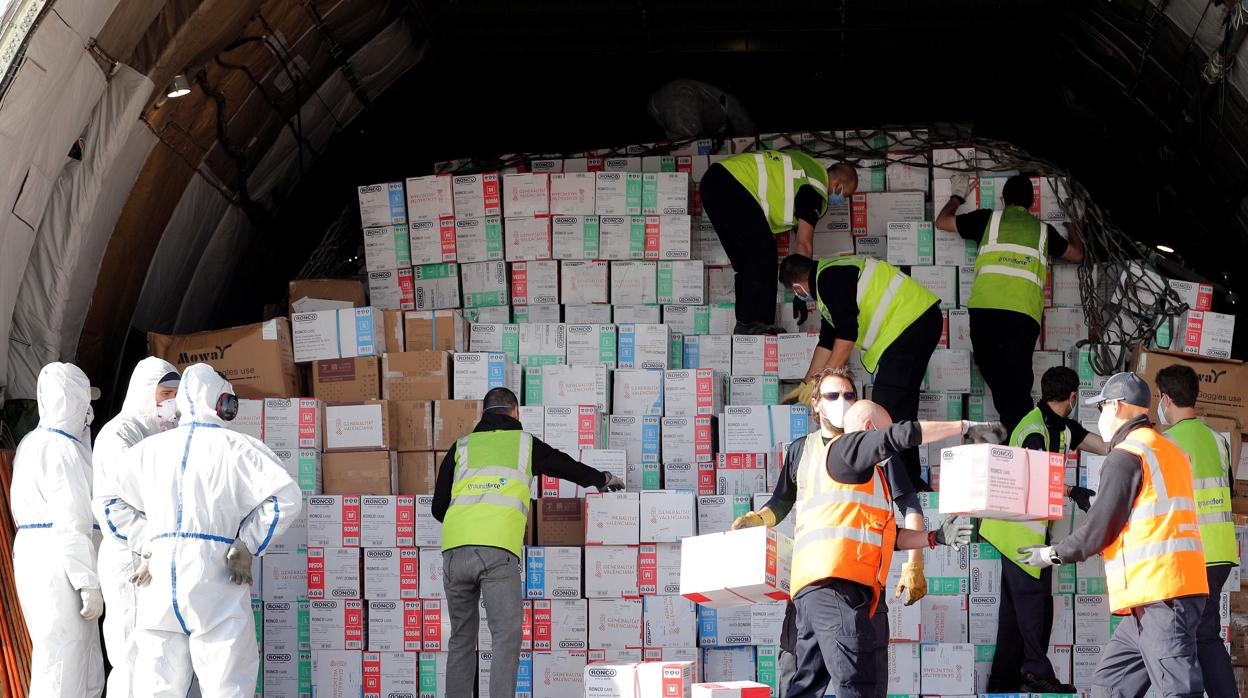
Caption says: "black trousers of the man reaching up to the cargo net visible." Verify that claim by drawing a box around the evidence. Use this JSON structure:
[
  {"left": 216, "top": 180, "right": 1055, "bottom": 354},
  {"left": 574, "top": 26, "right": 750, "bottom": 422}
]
[{"left": 970, "top": 308, "right": 1040, "bottom": 432}]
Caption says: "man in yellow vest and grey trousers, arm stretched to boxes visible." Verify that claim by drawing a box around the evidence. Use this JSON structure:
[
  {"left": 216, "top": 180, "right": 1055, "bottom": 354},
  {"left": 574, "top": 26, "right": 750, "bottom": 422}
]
[{"left": 432, "top": 388, "right": 624, "bottom": 698}]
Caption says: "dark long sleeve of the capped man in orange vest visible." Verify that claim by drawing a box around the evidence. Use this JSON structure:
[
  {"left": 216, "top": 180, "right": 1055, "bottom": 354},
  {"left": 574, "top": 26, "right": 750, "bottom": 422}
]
[{"left": 1053, "top": 415, "right": 1153, "bottom": 564}]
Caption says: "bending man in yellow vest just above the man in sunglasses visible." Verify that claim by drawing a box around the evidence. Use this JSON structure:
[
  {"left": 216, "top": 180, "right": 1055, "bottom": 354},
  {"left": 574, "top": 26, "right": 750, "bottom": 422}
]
[{"left": 780, "top": 255, "right": 945, "bottom": 489}]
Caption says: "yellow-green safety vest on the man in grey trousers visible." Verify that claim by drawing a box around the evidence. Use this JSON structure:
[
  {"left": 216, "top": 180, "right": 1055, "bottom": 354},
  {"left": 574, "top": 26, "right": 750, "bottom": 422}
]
[{"left": 442, "top": 431, "right": 533, "bottom": 558}]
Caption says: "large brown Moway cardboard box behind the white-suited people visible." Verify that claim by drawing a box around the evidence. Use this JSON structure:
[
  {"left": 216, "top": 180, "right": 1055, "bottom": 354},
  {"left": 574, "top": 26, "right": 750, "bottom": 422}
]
[{"left": 147, "top": 317, "right": 300, "bottom": 400}]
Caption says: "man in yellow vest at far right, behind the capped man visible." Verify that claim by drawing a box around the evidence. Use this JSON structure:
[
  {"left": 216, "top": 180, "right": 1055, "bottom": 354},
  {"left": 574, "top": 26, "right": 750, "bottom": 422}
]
[{"left": 1157, "top": 363, "right": 1239, "bottom": 696}]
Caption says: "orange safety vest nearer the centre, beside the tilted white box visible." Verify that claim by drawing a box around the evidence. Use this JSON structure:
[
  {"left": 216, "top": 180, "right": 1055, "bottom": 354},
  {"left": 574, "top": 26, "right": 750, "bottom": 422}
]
[{"left": 790, "top": 432, "right": 897, "bottom": 613}]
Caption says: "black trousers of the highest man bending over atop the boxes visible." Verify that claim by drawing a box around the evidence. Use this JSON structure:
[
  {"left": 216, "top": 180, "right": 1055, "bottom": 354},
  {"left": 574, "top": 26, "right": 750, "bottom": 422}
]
[{"left": 698, "top": 165, "right": 780, "bottom": 325}]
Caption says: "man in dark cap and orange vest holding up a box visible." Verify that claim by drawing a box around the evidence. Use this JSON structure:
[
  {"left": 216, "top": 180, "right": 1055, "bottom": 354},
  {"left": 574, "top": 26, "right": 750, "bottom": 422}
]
[{"left": 1018, "top": 373, "right": 1217, "bottom": 698}]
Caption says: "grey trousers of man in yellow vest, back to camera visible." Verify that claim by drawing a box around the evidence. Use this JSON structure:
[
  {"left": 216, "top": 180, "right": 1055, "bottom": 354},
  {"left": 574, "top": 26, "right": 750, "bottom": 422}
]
[{"left": 442, "top": 546, "right": 524, "bottom": 698}]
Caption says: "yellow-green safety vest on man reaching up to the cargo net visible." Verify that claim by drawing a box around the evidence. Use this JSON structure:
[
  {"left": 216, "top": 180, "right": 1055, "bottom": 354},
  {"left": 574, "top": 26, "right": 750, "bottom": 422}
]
[{"left": 966, "top": 206, "right": 1048, "bottom": 322}]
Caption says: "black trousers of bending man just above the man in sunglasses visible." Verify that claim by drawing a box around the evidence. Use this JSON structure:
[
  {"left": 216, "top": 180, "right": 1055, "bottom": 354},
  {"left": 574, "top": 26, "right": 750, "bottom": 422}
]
[{"left": 871, "top": 303, "right": 938, "bottom": 489}]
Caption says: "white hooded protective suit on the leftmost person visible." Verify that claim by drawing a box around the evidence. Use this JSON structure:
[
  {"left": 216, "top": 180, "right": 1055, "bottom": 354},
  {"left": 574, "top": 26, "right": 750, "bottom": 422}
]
[{"left": 10, "top": 363, "right": 104, "bottom": 698}]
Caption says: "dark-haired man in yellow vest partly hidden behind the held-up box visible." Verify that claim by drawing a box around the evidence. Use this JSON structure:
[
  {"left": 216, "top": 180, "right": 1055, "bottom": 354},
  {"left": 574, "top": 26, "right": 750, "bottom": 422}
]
[{"left": 980, "top": 366, "right": 1108, "bottom": 693}]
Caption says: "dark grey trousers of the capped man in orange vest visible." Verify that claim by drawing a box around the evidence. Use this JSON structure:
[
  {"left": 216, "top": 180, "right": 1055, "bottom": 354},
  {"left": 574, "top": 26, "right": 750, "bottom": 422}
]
[{"left": 1092, "top": 596, "right": 1207, "bottom": 698}]
